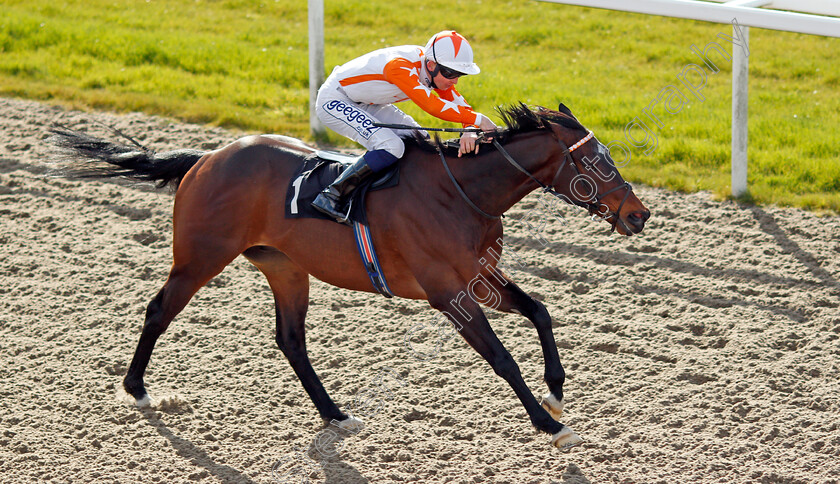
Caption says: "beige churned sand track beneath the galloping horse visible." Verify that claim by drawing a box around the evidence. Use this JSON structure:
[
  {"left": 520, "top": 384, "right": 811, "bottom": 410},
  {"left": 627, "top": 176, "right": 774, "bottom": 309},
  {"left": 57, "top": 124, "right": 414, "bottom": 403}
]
[{"left": 0, "top": 99, "right": 840, "bottom": 484}]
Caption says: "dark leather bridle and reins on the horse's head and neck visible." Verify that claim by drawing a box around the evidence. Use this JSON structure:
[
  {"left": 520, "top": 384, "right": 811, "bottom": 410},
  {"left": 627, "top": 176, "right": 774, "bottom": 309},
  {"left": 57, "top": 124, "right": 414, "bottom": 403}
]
[{"left": 440, "top": 120, "right": 633, "bottom": 232}]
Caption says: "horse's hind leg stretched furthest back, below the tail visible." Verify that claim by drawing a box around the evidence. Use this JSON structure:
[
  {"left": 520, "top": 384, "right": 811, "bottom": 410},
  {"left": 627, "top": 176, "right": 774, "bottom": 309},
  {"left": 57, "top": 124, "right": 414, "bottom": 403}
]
[{"left": 123, "top": 251, "right": 236, "bottom": 407}]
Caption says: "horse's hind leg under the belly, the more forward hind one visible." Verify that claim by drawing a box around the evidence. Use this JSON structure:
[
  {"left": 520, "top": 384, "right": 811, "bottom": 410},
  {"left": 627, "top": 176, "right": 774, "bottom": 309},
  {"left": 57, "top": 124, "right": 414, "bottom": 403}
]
[{"left": 242, "top": 247, "right": 361, "bottom": 429}]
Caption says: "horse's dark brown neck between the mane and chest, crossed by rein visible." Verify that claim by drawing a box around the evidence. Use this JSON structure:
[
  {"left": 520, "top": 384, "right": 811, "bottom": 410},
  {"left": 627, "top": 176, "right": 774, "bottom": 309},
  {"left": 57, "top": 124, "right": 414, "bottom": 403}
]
[{"left": 459, "top": 133, "right": 553, "bottom": 215}]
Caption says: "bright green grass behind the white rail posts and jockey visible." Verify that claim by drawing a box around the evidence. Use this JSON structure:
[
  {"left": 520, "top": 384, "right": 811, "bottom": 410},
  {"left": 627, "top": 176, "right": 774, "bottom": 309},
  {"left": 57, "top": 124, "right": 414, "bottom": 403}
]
[{"left": 0, "top": 0, "right": 840, "bottom": 213}]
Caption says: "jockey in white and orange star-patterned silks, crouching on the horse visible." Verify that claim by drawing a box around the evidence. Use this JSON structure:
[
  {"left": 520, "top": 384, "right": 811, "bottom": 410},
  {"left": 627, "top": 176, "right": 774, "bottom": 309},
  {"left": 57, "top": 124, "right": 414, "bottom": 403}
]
[{"left": 312, "top": 30, "right": 496, "bottom": 223}]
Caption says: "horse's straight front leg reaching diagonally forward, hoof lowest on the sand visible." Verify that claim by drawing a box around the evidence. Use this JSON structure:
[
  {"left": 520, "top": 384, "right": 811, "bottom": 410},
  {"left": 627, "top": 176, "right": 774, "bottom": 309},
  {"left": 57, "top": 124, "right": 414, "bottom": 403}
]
[{"left": 429, "top": 293, "right": 581, "bottom": 448}]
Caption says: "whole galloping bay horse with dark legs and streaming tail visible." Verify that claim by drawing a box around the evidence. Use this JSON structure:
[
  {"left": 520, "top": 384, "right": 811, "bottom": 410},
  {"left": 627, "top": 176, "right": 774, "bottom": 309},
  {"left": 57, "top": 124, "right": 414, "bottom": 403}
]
[{"left": 51, "top": 103, "right": 650, "bottom": 448}]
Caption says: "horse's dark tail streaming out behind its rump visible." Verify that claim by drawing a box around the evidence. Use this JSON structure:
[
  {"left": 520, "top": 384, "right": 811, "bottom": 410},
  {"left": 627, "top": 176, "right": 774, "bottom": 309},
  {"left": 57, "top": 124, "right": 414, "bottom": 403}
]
[{"left": 49, "top": 127, "right": 205, "bottom": 190}]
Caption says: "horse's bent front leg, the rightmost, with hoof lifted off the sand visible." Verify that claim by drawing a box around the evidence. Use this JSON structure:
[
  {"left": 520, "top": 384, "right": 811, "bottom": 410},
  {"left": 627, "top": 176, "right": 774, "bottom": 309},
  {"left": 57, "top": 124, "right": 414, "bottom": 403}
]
[{"left": 479, "top": 270, "right": 566, "bottom": 420}]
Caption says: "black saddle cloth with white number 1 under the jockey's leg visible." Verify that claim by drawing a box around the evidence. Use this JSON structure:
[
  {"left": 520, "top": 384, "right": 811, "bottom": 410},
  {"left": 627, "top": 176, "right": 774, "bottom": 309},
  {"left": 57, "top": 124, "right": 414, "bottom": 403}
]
[{"left": 286, "top": 151, "right": 399, "bottom": 224}]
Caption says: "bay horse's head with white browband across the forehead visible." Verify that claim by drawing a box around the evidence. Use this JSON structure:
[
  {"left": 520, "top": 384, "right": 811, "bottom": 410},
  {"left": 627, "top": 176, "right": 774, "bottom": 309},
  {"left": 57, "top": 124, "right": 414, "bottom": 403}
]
[{"left": 534, "top": 104, "right": 650, "bottom": 235}]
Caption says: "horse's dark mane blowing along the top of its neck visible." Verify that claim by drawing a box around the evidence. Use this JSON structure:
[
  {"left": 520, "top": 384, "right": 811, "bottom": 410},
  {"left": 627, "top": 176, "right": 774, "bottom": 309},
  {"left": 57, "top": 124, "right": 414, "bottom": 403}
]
[{"left": 405, "top": 102, "right": 586, "bottom": 156}]
